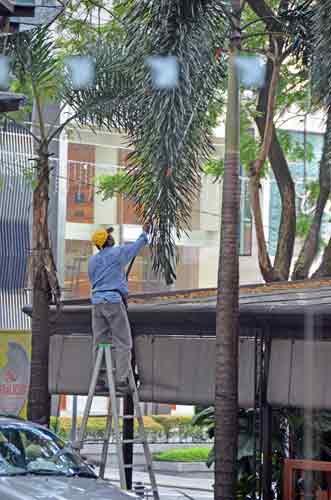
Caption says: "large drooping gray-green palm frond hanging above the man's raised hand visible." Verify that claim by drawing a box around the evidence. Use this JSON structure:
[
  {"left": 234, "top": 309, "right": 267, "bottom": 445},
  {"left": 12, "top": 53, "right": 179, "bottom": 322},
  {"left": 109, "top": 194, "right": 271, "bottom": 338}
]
[{"left": 118, "top": 0, "right": 230, "bottom": 283}]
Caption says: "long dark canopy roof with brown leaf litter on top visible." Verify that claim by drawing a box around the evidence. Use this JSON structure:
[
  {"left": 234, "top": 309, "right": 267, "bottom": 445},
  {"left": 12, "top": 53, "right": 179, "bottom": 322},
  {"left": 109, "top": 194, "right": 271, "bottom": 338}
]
[{"left": 24, "top": 280, "right": 331, "bottom": 338}]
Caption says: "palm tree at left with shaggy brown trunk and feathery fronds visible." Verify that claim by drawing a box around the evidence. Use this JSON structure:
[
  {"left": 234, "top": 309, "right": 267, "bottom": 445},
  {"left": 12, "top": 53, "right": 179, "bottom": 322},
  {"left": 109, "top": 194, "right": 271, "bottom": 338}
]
[{"left": 8, "top": 26, "right": 129, "bottom": 424}]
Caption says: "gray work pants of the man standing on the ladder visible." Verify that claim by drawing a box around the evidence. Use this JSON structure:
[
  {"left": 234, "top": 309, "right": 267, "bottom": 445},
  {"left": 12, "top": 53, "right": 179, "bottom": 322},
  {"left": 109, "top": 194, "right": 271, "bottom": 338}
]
[{"left": 92, "top": 301, "right": 132, "bottom": 383}]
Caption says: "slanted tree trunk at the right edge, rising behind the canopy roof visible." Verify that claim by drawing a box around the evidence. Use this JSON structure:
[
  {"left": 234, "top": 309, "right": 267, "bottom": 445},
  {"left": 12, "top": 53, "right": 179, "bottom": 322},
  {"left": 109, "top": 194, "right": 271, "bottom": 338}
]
[{"left": 292, "top": 108, "right": 331, "bottom": 280}]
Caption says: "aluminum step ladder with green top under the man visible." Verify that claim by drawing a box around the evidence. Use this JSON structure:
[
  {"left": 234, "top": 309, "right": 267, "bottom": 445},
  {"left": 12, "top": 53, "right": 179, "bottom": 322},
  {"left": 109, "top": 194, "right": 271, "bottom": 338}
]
[{"left": 74, "top": 343, "right": 159, "bottom": 500}]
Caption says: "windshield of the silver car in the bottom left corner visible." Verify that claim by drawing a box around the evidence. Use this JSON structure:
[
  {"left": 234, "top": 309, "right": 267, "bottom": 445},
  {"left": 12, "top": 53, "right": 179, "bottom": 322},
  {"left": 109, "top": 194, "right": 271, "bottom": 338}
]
[{"left": 0, "top": 424, "right": 96, "bottom": 477}]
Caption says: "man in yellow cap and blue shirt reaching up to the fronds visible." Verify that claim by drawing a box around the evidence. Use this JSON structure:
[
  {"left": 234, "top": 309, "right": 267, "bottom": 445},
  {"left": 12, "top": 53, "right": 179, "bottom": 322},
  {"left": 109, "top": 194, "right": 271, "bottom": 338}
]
[{"left": 88, "top": 224, "right": 149, "bottom": 393}]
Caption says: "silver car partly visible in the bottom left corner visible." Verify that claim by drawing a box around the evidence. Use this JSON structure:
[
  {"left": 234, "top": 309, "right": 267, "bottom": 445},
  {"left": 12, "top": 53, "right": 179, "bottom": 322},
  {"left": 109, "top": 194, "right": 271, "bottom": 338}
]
[{"left": 0, "top": 416, "right": 136, "bottom": 500}]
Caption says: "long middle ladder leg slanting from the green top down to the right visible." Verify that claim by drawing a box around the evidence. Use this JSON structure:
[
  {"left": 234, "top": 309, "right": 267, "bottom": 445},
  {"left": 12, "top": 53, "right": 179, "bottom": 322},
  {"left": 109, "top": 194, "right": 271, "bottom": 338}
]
[{"left": 105, "top": 345, "right": 127, "bottom": 490}]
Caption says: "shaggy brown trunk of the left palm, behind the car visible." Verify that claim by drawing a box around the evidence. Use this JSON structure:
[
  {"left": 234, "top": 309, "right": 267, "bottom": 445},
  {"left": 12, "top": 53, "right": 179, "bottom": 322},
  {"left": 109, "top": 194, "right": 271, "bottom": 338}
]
[{"left": 28, "top": 143, "right": 59, "bottom": 425}]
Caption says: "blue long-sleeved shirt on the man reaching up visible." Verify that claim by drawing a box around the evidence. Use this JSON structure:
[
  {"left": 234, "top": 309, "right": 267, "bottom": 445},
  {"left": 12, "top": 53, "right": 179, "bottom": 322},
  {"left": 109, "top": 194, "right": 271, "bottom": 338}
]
[{"left": 88, "top": 233, "right": 148, "bottom": 304}]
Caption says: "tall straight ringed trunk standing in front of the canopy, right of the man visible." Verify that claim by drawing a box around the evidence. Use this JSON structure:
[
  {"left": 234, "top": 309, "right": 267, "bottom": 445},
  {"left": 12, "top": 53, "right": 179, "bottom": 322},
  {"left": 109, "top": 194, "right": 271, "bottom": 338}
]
[{"left": 215, "top": 0, "right": 240, "bottom": 500}]
